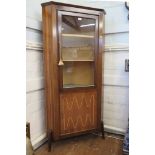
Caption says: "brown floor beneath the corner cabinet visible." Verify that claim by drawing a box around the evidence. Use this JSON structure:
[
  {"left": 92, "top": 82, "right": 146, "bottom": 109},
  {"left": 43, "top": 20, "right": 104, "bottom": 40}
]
[{"left": 35, "top": 134, "right": 123, "bottom": 155}]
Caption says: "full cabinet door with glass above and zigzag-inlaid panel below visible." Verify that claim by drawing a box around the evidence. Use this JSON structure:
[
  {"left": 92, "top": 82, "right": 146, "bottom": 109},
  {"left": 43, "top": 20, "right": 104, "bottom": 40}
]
[{"left": 58, "top": 11, "right": 98, "bottom": 135}]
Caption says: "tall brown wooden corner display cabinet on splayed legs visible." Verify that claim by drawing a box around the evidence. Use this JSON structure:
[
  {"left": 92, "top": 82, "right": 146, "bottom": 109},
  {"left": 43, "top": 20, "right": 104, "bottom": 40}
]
[{"left": 42, "top": 1, "right": 105, "bottom": 151}]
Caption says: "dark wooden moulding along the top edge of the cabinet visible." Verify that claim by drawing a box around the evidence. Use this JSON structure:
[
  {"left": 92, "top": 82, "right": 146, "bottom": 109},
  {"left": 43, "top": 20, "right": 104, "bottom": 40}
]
[{"left": 41, "top": 1, "right": 106, "bottom": 14}]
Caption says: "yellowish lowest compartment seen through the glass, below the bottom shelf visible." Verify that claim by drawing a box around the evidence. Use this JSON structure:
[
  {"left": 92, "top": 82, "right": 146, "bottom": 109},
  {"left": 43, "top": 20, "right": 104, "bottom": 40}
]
[{"left": 63, "top": 61, "right": 94, "bottom": 88}]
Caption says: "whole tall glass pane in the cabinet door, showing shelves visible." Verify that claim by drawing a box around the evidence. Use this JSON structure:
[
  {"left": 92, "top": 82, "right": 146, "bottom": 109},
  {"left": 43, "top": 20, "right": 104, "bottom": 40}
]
[{"left": 61, "top": 15, "right": 95, "bottom": 88}]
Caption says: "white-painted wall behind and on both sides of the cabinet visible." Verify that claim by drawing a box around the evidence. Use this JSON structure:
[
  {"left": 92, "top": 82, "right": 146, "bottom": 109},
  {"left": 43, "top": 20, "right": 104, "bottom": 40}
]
[{"left": 26, "top": 0, "right": 129, "bottom": 148}]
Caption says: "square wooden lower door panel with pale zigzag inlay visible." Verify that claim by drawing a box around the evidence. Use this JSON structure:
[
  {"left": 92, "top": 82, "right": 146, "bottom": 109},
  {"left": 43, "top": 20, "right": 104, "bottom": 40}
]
[{"left": 60, "top": 91, "right": 97, "bottom": 135}]
